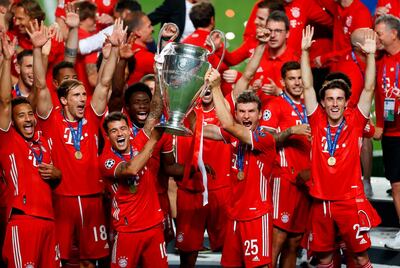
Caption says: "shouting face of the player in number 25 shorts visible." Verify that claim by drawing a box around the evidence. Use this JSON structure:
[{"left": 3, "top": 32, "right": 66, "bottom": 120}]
[{"left": 235, "top": 102, "right": 261, "bottom": 130}]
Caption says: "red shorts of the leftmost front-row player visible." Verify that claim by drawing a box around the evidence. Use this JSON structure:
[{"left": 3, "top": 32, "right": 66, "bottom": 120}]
[{"left": 3, "top": 215, "right": 60, "bottom": 268}]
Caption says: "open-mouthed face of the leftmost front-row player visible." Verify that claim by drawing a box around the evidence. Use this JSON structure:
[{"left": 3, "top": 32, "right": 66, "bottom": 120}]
[{"left": 12, "top": 103, "right": 36, "bottom": 139}]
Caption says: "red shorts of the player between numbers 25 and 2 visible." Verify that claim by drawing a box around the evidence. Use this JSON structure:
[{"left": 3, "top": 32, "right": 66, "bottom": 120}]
[{"left": 272, "top": 178, "right": 310, "bottom": 233}]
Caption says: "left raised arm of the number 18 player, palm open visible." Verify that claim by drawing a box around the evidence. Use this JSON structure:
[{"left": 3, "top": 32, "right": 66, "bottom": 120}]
[{"left": 27, "top": 20, "right": 53, "bottom": 118}]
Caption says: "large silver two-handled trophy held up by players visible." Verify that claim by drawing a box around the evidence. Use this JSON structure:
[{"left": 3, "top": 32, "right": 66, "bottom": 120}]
[{"left": 156, "top": 23, "right": 225, "bottom": 136}]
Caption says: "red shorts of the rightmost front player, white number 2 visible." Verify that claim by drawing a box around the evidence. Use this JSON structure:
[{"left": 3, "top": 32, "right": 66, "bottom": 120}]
[{"left": 308, "top": 198, "right": 376, "bottom": 253}]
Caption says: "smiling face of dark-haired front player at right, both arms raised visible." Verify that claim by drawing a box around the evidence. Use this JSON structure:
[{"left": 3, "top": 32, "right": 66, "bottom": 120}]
[{"left": 321, "top": 88, "right": 347, "bottom": 125}]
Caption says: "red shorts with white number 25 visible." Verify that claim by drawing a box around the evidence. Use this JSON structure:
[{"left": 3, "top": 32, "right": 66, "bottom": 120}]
[{"left": 221, "top": 216, "right": 272, "bottom": 267}]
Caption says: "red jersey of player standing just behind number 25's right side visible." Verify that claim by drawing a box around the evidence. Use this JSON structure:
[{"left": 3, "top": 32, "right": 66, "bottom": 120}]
[{"left": 260, "top": 94, "right": 311, "bottom": 183}]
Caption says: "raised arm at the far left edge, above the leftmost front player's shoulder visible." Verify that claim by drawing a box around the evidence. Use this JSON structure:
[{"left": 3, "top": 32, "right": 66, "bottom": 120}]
[{"left": 0, "top": 32, "right": 15, "bottom": 130}]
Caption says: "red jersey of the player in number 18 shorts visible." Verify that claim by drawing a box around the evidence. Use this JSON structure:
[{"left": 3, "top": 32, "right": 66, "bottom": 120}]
[{"left": 38, "top": 104, "right": 103, "bottom": 196}]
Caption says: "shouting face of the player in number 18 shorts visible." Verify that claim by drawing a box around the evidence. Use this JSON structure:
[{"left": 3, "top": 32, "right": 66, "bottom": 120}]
[{"left": 60, "top": 85, "right": 87, "bottom": 120}]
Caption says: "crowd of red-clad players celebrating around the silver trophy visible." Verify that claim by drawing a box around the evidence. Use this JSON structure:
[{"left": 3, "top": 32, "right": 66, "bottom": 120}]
[{"left": 0, "top": 0, "right": 400, "bottom": 268}]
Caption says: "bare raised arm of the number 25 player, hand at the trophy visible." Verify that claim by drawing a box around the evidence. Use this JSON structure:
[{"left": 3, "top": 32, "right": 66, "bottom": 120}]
[{"left": 206, "top": 69, "right": 252, "bottom": 144}]
